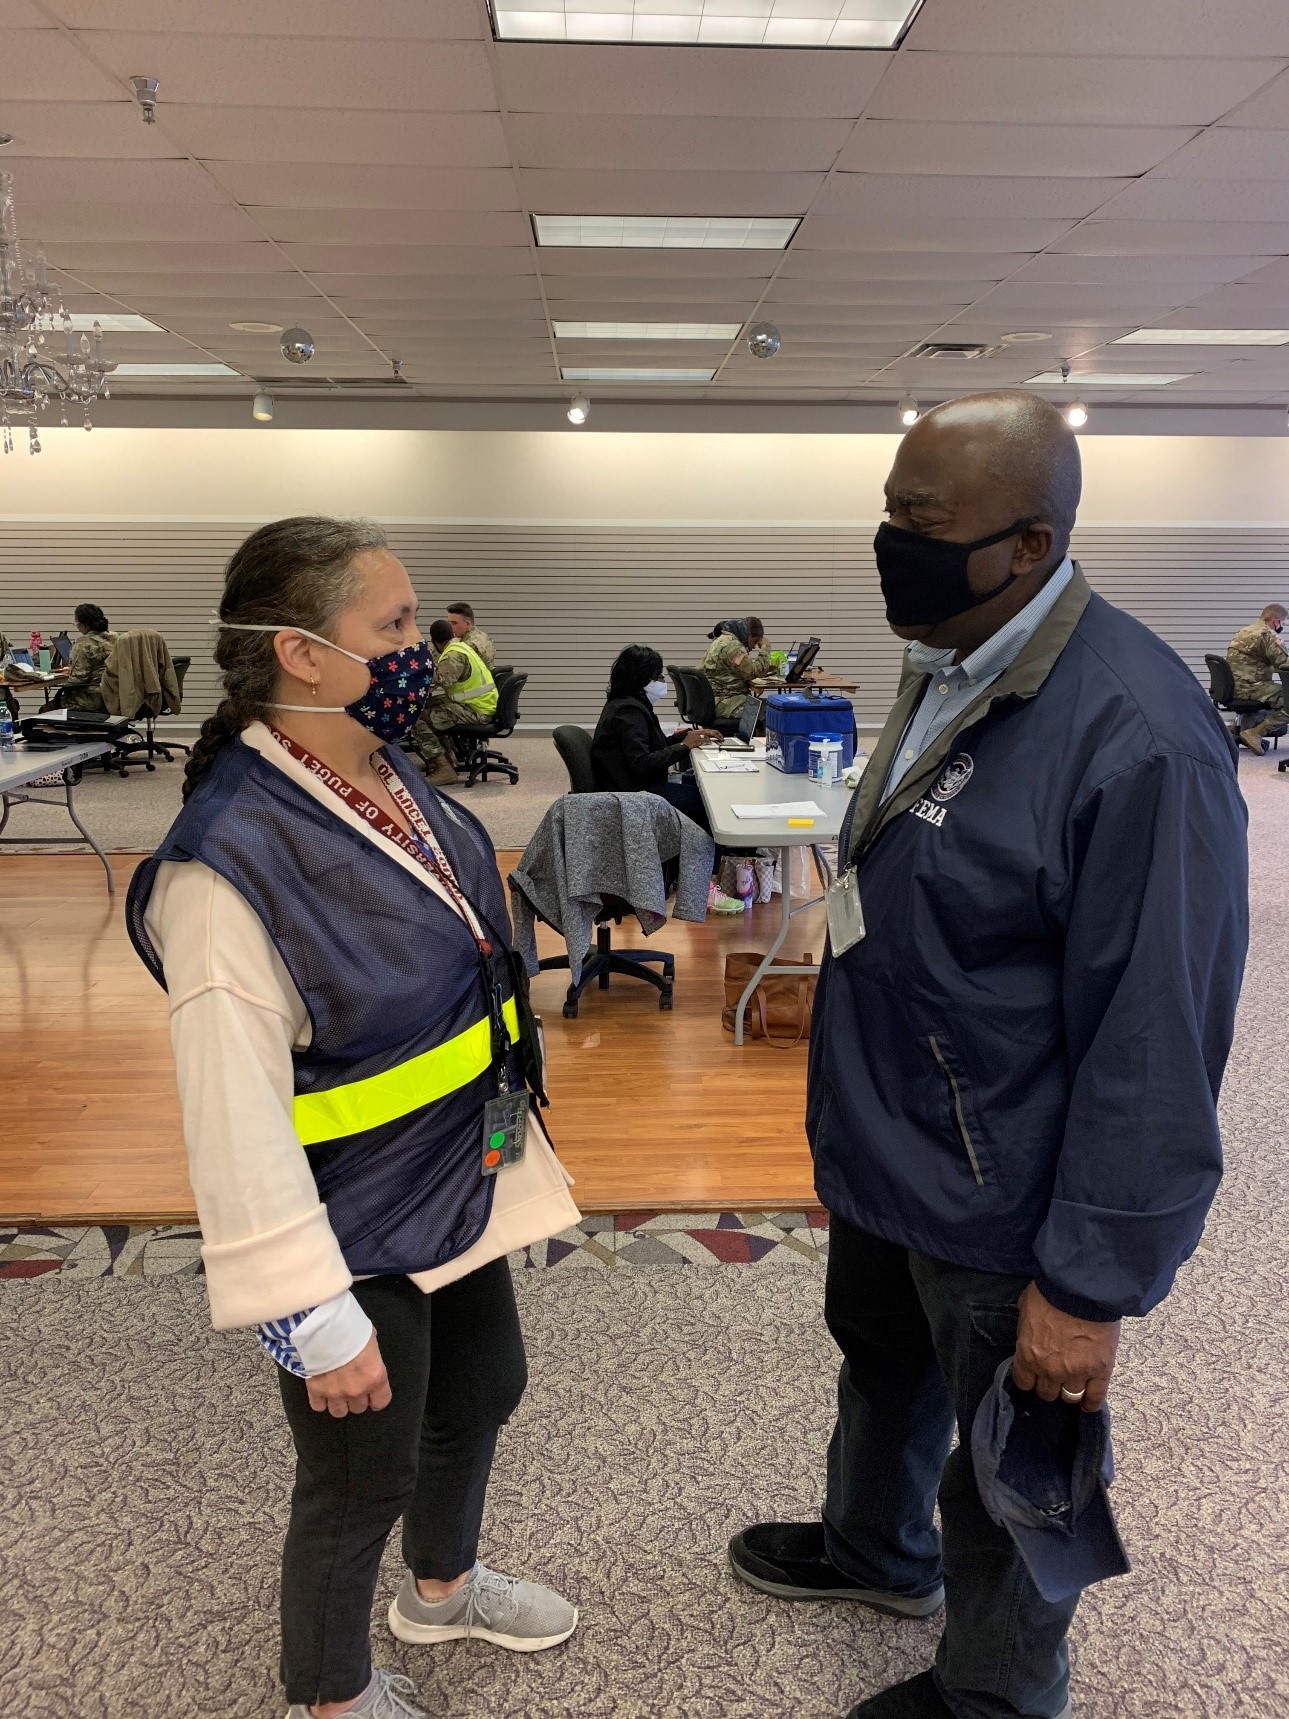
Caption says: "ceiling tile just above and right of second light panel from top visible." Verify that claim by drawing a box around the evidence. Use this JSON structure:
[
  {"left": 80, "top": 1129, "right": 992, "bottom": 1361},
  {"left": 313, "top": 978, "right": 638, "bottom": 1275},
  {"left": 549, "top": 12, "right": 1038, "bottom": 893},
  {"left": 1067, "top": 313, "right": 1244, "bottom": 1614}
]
[{"left": 811, "top": 172, "right": 1133, "bottom": 220}]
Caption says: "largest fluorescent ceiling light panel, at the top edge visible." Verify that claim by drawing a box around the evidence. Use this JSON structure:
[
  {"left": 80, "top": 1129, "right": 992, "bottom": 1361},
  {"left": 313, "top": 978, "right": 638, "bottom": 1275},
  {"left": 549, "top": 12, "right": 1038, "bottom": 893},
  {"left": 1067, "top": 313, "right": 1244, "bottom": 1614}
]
[{"left": 490, "top": 0, "right": 921, "bottom": 48}]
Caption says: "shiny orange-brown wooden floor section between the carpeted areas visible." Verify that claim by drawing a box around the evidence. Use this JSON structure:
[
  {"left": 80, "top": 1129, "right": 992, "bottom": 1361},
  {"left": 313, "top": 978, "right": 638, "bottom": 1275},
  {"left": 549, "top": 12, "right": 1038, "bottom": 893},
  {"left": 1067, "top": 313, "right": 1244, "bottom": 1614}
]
[{"left": 0, "top": 854, "right": 825, "bottom": 1224}]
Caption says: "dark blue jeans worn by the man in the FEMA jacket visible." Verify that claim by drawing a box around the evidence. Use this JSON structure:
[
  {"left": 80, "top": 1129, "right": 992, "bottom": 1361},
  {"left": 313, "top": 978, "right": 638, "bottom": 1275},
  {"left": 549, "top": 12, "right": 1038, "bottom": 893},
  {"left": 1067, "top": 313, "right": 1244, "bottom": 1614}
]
[{"left": 823, "top": 1214, "right": 1078, "bottom": 1719}]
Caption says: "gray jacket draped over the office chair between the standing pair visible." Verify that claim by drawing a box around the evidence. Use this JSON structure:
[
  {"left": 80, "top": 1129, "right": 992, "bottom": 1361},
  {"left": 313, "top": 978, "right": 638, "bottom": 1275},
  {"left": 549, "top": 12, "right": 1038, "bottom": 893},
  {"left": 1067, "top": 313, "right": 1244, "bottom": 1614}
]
[{"left": 510, "top": 794, "right": 713, "bottom": 985}]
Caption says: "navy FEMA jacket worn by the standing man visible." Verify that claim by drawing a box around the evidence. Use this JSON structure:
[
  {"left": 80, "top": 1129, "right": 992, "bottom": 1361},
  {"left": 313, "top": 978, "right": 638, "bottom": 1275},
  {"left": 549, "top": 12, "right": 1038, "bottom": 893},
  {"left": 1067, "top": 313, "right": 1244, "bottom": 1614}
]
[{"left": 818, "top": 566, "right": 1248, "bottom": 1320}]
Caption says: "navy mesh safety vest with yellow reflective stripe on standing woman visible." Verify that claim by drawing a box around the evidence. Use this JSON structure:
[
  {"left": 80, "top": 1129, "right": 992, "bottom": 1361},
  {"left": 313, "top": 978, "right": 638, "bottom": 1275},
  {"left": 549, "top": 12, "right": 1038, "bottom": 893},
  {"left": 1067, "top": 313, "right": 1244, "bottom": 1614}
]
[{"left": 127, "top": 739, "right": 524, "bottom": 1275}]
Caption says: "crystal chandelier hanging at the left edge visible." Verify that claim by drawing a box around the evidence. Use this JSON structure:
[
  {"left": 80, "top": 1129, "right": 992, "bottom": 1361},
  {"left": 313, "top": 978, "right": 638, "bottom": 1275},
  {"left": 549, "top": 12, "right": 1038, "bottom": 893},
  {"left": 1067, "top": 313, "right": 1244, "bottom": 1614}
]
[{"left": 0, "top": 174, "right": 115, "bottom": 454}]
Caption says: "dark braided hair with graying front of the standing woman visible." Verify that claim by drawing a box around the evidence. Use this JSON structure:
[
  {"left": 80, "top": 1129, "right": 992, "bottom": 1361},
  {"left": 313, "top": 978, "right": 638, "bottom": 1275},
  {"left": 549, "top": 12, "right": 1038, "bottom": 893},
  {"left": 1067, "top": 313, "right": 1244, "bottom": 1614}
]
[{"left": 184, "top": 516, "right": 387, "bottom": 799}]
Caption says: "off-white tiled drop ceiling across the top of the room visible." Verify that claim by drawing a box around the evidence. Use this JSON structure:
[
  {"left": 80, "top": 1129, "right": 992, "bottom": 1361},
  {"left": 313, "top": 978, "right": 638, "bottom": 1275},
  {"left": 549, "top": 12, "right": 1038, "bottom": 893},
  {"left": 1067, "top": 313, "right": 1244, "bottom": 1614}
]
[{"left": 0, "top": 0, "right": 1289, "bottom": 406}]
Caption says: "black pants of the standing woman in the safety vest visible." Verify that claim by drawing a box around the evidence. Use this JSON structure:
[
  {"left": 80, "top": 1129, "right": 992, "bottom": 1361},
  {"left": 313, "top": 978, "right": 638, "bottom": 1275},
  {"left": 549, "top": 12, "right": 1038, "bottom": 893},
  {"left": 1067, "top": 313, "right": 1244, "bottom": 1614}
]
[{"left": 278, "top": 1258, "right": 528, "bottom": 1704}]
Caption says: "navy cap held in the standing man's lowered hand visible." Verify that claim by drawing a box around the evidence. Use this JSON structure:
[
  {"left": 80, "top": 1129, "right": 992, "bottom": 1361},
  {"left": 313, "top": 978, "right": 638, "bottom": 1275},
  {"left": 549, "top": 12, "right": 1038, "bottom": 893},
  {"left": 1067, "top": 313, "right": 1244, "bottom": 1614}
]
[{"left": 971, "top": 1361, "right": 1133, "bottom": 1602}]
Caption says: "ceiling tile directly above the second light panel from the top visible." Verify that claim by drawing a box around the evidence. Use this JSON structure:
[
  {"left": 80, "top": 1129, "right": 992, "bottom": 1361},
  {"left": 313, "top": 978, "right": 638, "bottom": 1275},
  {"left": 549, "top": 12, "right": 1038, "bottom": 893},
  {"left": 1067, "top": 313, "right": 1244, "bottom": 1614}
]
[{"left": 521, "top": 165, "right": 825, "bottom": 215}]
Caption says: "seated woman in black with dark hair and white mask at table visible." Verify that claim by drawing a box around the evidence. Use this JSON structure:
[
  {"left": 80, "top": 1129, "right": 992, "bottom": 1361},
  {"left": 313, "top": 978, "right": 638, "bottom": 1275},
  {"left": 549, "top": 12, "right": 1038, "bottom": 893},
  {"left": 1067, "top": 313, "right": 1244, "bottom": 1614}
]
[{"left": 591, "top": 645, "right": 742, "bottom": 913}]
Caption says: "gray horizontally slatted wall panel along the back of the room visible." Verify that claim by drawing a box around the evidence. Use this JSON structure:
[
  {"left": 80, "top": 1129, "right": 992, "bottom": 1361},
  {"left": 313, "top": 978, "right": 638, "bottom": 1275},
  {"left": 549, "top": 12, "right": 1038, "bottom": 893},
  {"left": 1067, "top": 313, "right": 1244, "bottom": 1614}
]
[{"left": 0, "top": 519, "right": 1289, "bottom": 725}]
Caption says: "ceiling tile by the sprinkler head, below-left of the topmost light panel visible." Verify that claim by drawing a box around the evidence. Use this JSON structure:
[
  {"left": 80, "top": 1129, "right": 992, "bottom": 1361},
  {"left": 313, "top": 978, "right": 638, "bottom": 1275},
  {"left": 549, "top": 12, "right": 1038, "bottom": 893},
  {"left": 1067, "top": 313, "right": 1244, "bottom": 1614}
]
[{"left": 74, "top": 29, "right": 497, "bottom": 120}]
